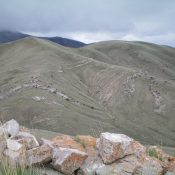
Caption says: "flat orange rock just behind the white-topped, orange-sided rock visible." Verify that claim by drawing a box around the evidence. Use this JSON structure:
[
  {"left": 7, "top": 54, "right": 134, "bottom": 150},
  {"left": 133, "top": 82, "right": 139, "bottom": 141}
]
[{"left": 51, "top": 135, "right": 85, "bottom": 152}]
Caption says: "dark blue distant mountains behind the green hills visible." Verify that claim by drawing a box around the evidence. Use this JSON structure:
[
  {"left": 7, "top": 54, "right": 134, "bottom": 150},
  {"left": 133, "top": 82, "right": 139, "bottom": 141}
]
[{"left": 0, "top": 31, "right": 86, "bottom": 48}]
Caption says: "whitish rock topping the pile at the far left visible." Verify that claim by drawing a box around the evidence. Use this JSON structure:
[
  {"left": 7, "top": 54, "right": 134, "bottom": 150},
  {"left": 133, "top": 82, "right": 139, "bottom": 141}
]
[{"left": 2, "top": 119, "right": 19, "bottom": 137}]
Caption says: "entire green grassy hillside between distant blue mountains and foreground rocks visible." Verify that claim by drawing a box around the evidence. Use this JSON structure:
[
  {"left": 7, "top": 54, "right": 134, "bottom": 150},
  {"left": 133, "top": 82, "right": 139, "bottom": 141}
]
[{"left": 0, "top": 38, "right": 175, "bottom": 146}]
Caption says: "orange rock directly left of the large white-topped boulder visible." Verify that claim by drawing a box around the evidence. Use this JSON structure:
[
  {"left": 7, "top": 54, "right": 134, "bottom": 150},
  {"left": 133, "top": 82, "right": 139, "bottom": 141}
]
[{"left": 76, "top": 135, "right": 97, "bottom": 156}]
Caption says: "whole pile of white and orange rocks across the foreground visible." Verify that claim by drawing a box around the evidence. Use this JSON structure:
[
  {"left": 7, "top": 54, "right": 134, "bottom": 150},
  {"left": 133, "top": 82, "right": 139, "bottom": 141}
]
[{"left": 0, "top": 120, "right": 175, "bottom": 175}]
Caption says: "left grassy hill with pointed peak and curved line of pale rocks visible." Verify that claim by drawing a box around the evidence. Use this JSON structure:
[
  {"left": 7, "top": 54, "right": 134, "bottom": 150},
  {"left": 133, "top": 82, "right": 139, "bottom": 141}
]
[{"left": 0, "top": 38, "right": 114, "bottom": 134}]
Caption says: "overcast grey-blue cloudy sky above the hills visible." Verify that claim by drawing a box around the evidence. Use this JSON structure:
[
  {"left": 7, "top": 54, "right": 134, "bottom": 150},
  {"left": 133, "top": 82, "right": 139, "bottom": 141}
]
[{"left": 0, "top": 0, "right": 175, "bottom": 46}]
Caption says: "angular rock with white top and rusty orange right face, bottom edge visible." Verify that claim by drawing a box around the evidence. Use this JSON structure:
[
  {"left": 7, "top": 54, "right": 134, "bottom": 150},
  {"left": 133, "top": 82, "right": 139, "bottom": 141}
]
[{"left": 52, "top": 148, "right": 88, "bottom": 175}]
